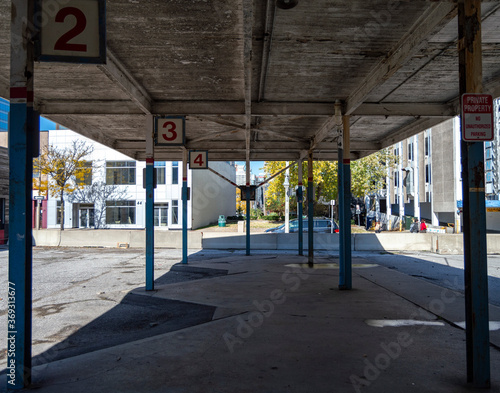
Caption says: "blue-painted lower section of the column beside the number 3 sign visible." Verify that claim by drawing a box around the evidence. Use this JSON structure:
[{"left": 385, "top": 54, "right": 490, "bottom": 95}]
[{"left": 146, "top": 158, "right": 155, "bottom": 291}]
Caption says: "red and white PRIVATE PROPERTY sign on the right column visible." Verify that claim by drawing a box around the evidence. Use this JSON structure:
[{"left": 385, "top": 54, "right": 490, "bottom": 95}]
[{"left": 462, "top": 94, "right": 495, "bottom": 142}]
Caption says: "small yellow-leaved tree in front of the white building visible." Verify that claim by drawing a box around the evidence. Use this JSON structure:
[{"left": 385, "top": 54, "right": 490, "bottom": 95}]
[{"left": 33, "top": 140, "right": 94, "bottom": 230}]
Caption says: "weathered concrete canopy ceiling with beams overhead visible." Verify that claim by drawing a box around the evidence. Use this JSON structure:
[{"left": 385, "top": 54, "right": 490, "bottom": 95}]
[{"left": 0, "top": 0, "right": 500, "bottom": 161}]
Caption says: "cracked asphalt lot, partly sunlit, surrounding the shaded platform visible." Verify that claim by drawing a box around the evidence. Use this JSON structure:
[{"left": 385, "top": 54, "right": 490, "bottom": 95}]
[{"left": 0, "top": 247, "right": 500, "bottom": 373}]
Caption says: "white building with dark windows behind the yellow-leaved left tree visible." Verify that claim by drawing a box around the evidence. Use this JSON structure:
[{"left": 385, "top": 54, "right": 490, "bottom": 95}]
[{"left": 47, "top": 130, "right": 236, "bottom": 230}]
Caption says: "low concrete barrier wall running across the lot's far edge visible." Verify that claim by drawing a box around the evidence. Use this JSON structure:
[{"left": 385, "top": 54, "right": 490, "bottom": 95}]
[{"left": 33, "top": 229, "right": 500, "bottom": 254}]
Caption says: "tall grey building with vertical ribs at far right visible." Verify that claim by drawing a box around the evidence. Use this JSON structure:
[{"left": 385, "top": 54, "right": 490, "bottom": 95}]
[{"left": 384, "top": 100, "right": 500, "bottom": 232}]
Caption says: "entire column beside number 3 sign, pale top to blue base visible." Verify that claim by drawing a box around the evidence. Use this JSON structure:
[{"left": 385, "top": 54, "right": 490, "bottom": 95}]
[{"left": 145, "top": 116, "right": 155, "bottom": 291}]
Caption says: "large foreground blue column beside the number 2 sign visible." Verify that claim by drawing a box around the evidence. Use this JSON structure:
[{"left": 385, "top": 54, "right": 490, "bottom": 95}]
[{"left": 5, "top": 0, "right": 36, "bottom": 390}]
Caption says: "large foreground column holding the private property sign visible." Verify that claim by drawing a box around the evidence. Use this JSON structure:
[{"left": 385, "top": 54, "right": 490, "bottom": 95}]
[{"left": 458, "top": 0, "right": 491, "bottom": 388}]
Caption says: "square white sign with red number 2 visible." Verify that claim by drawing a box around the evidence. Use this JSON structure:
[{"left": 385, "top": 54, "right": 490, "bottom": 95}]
[{"left": 35, "top": 0, "right": 106, "bottom": 64}]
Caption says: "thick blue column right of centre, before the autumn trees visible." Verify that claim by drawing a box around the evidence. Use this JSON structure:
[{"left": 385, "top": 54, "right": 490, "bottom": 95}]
[{"left": 339, "top": 116, "right": 352, "bottom": 289}]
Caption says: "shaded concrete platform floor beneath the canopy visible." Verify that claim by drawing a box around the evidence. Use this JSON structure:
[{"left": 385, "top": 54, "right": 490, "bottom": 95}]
[{"left": 0, "top": 255, "right": 500, "bottom": 393}]
